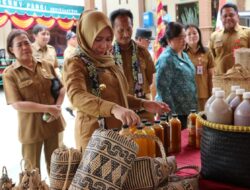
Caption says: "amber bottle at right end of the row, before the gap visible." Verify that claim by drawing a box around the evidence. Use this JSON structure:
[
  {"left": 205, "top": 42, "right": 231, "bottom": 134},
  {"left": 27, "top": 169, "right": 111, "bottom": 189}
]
[{"left": 169, "top": 114, "right": 181, "bottom": 153}]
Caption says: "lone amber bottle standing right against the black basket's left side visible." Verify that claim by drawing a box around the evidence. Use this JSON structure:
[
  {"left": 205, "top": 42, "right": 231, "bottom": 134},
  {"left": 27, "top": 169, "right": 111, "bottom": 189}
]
[{"left": 187, "top": 109, "right": 197, "bottom": 147}]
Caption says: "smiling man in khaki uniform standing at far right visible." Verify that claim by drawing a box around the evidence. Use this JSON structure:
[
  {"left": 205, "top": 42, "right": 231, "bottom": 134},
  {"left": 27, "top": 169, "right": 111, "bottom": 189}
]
[{"left": 209, "top": 3, "right": 250, "bottom": 74}]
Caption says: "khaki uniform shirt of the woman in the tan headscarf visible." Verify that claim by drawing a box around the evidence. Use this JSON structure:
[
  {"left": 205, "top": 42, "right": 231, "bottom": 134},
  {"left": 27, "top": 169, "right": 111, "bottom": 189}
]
[{"left": 63, "top": 56, "right": 141, "bottom": 149}]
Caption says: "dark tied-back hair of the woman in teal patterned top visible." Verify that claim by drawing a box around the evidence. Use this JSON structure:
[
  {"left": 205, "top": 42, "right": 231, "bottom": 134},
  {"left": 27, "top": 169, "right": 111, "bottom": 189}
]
[{"left": 160, "top": 22, "right": 184, "bottom": 47}]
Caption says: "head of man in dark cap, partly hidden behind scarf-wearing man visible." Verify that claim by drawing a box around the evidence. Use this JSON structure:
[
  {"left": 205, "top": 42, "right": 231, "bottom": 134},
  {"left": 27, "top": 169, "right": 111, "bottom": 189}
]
[{"left": 135, "top": 28, "right": 154, "bottom": 49}]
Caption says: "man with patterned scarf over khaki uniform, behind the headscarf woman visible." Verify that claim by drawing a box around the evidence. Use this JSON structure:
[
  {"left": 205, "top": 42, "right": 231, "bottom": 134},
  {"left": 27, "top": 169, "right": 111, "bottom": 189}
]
[{"left": 110, "top": 9, "right": 155, "bottom": 121}]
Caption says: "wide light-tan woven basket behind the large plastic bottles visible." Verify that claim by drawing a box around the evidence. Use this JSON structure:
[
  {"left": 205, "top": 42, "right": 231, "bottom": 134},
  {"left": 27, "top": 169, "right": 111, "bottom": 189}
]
[{"left": 212, "top": 64, "right": 250, "bottom": 96}]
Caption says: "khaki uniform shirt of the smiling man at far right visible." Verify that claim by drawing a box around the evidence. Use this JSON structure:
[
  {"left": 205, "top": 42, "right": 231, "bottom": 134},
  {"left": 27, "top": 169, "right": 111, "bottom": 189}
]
[{"left": 209, "top": 25, "right": 250, "bottom": 74}]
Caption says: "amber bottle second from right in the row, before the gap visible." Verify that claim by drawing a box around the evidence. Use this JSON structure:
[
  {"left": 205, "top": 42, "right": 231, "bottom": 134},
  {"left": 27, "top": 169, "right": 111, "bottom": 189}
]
[{"left": 160, "top": 115, "right": 170, "bottom": 154}]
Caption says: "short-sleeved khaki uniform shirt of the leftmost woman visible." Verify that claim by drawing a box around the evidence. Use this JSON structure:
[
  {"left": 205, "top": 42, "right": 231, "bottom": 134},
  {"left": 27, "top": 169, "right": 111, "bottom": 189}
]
[{"left": 3, "top": 58, "right": 65, "bottom": 144}]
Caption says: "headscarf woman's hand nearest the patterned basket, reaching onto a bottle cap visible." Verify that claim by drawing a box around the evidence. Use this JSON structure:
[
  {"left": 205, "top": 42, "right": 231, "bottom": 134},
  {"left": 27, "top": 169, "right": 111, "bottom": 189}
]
[{"left": 111, "top": 105, "right": 140, "bottom": 126}]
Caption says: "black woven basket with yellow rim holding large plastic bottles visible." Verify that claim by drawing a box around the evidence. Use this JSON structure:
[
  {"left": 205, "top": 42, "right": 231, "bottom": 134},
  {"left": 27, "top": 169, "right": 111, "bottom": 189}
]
[{"left": 197, "top": 113, "right": 250, "bottom": 188}]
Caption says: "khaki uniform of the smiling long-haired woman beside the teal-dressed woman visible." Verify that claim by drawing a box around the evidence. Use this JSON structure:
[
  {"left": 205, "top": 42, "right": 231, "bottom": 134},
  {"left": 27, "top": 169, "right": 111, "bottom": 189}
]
[{"left": 187, "top": 47, "right": 214, "bottom": 98}]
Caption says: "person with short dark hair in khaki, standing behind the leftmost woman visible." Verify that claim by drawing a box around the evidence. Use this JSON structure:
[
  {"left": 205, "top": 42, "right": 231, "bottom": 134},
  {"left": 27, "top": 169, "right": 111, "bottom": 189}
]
[{"left": 32, "top": 24, "right": 61, "bottom": 77}]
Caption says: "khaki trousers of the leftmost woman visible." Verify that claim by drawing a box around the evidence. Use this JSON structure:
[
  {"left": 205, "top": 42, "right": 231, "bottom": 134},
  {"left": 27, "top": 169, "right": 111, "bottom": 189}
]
[{"left": 22, "top": 134, "right": 59, "bottom": 174}]
